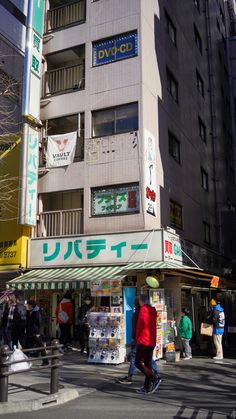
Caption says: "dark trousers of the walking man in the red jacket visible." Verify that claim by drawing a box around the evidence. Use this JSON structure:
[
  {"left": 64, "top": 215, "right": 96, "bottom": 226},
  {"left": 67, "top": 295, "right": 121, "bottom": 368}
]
[{"left": 135, "top": 345, "right": 154, "bottom": 391}]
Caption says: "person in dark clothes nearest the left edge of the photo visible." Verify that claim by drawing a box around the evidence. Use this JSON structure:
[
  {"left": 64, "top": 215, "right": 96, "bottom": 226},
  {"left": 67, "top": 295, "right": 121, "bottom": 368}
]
[{"left": 2, "top": 294, "right": 21, "bottom": 350}]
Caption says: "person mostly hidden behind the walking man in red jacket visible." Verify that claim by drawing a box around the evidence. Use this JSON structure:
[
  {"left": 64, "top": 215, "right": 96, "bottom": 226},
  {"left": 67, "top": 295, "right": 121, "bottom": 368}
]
[{"left": 118, "top": 297, "right": 161, "bottom": 384}]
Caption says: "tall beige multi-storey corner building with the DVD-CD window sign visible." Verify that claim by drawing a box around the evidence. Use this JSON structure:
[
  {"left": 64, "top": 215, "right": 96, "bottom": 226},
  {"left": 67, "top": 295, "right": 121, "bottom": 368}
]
[{"left": 6, "top": 0, "right": 236, "bottom": 344}]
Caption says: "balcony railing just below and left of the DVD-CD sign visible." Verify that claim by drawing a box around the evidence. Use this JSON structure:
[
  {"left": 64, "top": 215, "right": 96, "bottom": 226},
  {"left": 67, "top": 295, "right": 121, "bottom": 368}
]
[{"left": 43, "top": 64, "right": 85, "bottom": 97}]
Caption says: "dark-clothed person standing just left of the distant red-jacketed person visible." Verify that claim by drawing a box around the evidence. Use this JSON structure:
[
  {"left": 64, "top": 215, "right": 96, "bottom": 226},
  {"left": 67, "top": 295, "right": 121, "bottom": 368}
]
[{"left": 26, "top": 301, "right": 49, "bottom": 365}]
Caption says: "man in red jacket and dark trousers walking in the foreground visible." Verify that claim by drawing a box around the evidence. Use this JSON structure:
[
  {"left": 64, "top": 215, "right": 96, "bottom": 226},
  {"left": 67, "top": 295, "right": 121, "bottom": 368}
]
[{"left": 135, "top": 294, "right": 159, "bottom": 394}]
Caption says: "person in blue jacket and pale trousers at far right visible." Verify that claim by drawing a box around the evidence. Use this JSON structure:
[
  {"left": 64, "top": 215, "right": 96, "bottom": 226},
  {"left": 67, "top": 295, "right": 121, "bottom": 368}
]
[{"left": 207, "top": 298, "right": 225, "bottom": 360}]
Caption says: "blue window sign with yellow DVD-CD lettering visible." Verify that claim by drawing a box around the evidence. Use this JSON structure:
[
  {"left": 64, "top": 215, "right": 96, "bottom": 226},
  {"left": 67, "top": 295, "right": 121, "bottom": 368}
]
[{"left": 93, "top": 31, "right": 138, "bottom": 66}]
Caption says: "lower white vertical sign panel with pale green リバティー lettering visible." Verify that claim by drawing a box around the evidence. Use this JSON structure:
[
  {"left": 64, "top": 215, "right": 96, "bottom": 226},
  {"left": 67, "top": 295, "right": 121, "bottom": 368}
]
[{"left": 24, "top": 125, "right": 39, "bottom": 226}]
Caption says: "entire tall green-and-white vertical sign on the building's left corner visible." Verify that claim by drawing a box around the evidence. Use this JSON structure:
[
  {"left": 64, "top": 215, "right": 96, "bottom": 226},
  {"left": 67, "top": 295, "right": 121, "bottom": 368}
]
[{"left": 18, "top": 0, "right": 44, "bottom": 226}]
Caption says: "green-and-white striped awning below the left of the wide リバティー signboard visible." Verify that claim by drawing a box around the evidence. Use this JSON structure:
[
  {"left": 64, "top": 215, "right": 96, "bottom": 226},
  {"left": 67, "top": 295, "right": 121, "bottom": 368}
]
[{"left": 7, "top": 266, "right": 124, "bottom": 290}]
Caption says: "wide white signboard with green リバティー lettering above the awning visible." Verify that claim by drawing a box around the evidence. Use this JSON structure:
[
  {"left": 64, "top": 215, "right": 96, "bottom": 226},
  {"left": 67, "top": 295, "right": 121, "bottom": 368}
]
[{"left": 29, "top": 230, "right": 162, "bottom": 268}]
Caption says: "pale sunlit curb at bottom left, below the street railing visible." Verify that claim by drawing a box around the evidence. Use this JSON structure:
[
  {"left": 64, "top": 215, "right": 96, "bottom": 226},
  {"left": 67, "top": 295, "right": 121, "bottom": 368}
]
[{"left": 0, "top": 387, "right": 96, "bottom": 415}]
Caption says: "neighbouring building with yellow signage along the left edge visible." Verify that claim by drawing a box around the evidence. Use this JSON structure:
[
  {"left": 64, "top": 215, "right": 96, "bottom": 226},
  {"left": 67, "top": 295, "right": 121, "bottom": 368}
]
[{"left": 0, "top": 0, "right": 30, "bottom": 290}]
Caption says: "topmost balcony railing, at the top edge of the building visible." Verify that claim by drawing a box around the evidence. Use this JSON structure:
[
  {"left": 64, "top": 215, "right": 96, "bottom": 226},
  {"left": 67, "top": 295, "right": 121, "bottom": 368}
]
[{"left": 46, "top": 0, "right": 86, "bottom": 32}]
